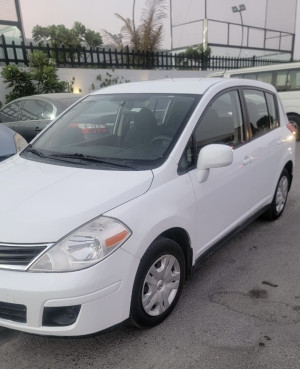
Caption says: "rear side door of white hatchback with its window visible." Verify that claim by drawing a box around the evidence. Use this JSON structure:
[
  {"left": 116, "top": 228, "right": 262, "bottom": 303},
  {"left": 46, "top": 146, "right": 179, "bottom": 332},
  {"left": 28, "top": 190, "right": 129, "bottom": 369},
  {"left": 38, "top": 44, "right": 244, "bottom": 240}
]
[{"left": 242, "top": 88, "right": 285, "bottom": 204}]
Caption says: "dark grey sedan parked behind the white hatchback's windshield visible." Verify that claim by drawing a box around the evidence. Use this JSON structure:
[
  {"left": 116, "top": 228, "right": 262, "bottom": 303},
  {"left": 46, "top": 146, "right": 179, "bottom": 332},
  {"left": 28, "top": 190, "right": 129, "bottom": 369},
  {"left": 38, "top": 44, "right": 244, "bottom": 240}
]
[{"left": 0, "top": 93, "right": 83, "bottom": 142}]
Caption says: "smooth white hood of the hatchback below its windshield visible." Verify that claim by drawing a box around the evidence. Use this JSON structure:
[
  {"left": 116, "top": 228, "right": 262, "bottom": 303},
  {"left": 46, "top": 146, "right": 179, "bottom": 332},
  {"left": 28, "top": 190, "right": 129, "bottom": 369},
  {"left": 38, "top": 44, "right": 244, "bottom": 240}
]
[{"left": 0, "top": 156, "right": 153, "bottom": 243}]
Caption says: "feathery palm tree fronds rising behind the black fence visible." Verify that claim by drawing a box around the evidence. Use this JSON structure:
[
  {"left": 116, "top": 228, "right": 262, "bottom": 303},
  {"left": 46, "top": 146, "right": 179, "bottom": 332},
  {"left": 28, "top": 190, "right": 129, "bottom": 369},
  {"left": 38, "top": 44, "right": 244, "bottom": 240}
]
[{"left": 104, "top": 0, "right": 166, "bottom": 52}]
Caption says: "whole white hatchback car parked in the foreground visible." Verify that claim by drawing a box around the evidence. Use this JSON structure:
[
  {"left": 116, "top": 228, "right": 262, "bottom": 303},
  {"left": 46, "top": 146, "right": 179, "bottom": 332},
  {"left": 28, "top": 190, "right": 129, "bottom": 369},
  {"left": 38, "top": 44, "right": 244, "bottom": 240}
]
[{"left": 0, "top": 78, "right": 295, "bottom": 336}]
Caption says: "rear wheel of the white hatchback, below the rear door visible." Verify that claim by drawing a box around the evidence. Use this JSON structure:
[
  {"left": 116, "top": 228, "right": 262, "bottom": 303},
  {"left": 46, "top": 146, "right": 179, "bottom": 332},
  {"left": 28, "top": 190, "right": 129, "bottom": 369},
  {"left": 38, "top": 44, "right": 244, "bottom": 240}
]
[{"left": 263, "top": 168, "right": 291, "bottom": 220}]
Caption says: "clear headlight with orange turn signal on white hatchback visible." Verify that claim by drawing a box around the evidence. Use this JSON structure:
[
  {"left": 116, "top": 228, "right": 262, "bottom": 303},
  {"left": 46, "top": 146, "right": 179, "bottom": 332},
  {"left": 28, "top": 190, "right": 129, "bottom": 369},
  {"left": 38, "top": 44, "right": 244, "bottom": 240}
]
[{"left": 29, "top": 216, "right": 131, "bottom": 272}]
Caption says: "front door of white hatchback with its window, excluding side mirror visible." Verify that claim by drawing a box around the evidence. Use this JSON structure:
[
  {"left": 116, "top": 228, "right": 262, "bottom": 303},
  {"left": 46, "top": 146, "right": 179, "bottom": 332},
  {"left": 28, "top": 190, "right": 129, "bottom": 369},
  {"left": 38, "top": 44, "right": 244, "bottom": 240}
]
[{"left": 184, "top": 90, "right": 270, "bottom": 258}]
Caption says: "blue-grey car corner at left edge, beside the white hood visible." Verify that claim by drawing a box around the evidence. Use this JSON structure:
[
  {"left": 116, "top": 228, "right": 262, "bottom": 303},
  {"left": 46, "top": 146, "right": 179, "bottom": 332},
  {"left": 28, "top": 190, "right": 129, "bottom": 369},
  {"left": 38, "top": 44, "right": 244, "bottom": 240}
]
[{"left": 0, "top": 124, "right": 27, "bottom": 161}]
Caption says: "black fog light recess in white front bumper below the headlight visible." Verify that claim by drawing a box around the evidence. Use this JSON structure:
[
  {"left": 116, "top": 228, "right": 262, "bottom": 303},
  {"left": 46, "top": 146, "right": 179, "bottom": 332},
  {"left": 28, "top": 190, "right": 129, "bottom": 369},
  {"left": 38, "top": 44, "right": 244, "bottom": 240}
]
[{"left": 43, "top": 305, "right": 81, "bottom": 327}]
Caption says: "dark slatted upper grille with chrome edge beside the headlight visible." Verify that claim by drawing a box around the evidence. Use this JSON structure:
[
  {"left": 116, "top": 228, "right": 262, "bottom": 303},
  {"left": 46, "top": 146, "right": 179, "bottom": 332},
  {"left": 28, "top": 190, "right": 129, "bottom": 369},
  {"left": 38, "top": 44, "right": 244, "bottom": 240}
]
[{"left": 0, "top": 243, "right": 49, "bottom": 270}]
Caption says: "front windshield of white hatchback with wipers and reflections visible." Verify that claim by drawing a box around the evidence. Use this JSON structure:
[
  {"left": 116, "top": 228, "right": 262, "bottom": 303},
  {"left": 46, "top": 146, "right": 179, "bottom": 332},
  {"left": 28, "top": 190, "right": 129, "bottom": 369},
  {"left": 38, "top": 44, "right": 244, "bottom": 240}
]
[{"left": 22, "top": 94, "right": 200, "bottom": 169}]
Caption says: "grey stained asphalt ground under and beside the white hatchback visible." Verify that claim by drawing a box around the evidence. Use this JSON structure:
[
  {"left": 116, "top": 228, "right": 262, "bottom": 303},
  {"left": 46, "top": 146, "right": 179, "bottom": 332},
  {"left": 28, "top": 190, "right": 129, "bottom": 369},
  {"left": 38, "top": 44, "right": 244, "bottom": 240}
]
[{"left": 0, "top": 143, "right": 300, "bottom": 369}]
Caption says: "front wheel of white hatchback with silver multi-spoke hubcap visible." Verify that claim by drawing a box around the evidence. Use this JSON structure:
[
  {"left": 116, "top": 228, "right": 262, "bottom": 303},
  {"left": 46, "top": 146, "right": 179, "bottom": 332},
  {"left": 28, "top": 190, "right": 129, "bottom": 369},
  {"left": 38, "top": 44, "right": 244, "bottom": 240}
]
[{"left": 130, "top": 237, "right": 185, "bottom": 328}]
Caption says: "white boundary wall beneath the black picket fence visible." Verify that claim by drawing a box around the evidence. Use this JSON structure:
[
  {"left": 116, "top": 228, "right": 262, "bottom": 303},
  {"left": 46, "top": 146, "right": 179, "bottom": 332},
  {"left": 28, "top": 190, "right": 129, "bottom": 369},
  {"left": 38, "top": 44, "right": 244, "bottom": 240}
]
[{"left": 0, "top": 67, "right": 209, "bottom": 103}]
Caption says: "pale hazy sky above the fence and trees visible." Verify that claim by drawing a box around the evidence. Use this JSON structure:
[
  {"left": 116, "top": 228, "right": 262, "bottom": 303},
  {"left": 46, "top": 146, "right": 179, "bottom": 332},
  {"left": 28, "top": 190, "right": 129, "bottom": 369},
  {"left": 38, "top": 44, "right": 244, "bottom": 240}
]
[{"left": 15, "top": 0, "right": 300, "bottom": 59}]
